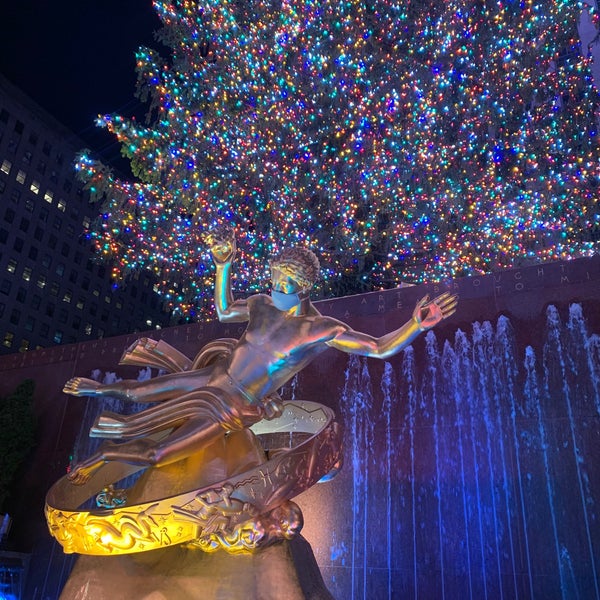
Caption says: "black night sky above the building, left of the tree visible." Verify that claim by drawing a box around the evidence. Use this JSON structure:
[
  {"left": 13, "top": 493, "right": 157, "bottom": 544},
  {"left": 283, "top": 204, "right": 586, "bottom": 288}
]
[{"left": 0, "top": 0, "right": 160, "bottom": 159}]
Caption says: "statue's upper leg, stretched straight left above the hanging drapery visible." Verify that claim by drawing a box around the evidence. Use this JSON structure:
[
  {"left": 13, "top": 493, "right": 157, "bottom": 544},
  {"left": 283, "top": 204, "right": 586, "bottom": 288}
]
[{"left": 63, "top": 368, "right": 211, "bottom": 402}]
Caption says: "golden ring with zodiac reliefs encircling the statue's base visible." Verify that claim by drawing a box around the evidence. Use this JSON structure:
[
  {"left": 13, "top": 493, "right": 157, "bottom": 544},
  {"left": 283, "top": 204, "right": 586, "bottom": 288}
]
[{"left": 45, "top": 402, "right": 341, "bottom": 556}]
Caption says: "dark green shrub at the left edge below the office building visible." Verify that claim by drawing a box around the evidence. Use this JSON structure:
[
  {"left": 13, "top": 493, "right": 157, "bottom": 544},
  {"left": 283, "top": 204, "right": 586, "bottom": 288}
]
[{"left": 0, "top": 379, "right": 35, "bottom": 509}]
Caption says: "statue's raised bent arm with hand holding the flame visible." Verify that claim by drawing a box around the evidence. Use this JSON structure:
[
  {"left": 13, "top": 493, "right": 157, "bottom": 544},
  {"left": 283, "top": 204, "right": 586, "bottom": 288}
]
[{"left": 205, "top": 225, "right": 249, "bottom": 323}]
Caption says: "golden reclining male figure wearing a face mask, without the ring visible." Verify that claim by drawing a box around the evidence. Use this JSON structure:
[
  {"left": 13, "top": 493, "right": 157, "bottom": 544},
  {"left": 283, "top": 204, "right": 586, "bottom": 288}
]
[{"left": 64, "top": 227, "right": 457, "bottom": 484}]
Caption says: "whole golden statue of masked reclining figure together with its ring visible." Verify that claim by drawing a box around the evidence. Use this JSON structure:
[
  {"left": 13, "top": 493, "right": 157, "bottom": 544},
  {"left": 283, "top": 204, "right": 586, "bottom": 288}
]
[{"left": 46, "top": 226, "right": 457, "bottom": 554}]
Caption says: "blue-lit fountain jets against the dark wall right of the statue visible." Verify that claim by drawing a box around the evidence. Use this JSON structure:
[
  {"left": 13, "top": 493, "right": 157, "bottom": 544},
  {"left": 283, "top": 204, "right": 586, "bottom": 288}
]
[{"left": 328, "top": 304, "right": 600, "bottom": 600}]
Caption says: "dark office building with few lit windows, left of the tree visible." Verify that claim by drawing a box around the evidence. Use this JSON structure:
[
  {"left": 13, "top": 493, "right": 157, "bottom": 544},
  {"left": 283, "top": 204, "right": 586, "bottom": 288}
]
[{"left": 0, "top": 75, "right": 169, "bottom": 354}]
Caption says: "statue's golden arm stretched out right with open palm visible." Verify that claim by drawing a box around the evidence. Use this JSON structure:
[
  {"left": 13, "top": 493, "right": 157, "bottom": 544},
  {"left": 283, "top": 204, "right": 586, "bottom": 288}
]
[{"left": 327, "top": 292, "right": 458, "bottom": 358}]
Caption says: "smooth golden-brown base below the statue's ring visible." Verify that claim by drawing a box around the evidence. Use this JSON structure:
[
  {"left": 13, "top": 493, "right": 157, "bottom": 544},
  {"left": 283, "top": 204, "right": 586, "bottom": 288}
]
[{"left": 60, "top": 536, "right": 333, "bottom": 600}]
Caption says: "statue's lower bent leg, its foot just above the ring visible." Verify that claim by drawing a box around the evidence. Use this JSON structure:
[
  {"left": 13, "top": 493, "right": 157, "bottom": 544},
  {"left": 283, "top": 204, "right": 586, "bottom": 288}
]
[{"left": 69, "top": 417, "right": 225, "bottom": 485}]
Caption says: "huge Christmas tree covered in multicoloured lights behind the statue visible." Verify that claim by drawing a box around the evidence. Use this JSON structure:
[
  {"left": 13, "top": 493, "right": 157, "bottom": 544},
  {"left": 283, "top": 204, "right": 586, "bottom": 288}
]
[{"left": 77, "top": 0, "right": 600, "bottom": 316}]
